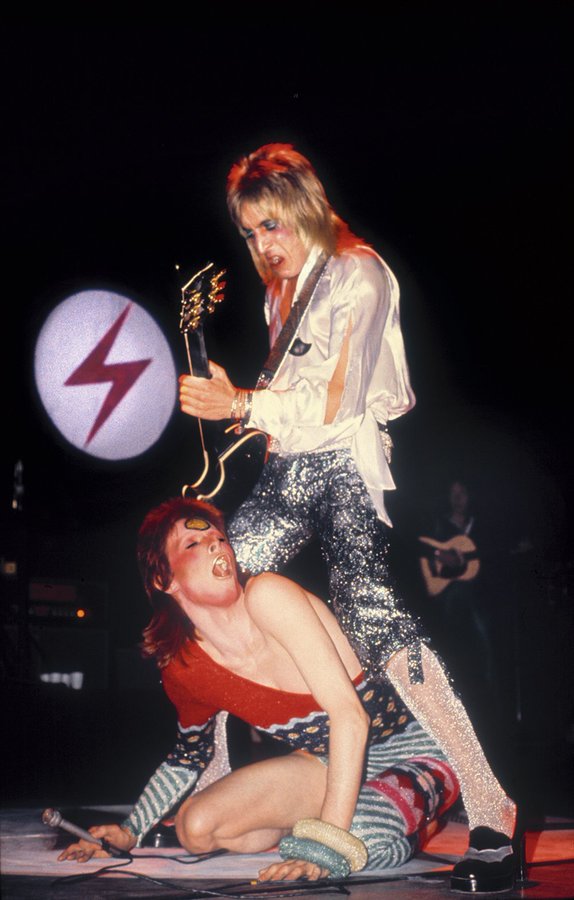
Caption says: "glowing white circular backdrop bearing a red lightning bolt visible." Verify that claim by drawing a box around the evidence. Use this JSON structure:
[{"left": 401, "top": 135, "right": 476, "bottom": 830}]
[{"left": 34, "top": 290, "right": 177, "bottom": 460}]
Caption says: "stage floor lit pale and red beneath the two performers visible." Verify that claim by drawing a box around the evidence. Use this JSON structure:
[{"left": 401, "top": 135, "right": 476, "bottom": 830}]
[{"left": 0, "top": 806, "right": 574, "bottom": 900}]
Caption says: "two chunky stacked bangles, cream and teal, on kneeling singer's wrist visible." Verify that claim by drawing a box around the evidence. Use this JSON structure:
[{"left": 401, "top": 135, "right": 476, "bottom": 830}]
[{"left": 279, "top": 819, "right": 369, "bottom": 878}]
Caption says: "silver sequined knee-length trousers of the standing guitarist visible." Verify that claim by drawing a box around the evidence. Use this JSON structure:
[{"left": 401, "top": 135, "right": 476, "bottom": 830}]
[{"left": 228, "top": 449, "right": 421, "bottom": 680}]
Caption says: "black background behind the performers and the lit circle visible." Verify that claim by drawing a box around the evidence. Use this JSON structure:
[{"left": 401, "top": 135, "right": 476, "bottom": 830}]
[{"left": 0, "top": 10, "right": 574, "bottom": 820}]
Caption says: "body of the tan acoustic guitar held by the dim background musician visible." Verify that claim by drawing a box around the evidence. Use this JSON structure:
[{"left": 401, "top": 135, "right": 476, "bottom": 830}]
[{"left": 419, "top": 534, "right": 480, "bottom": 597}]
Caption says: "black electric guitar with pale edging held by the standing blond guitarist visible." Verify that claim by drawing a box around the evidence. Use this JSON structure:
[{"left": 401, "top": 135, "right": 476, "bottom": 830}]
[{"left": 179, "top": 262, "right": 267, "bottom": 510}]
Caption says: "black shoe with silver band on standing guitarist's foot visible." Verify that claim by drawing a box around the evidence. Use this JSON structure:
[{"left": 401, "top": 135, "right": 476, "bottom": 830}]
[{"left": 450, "top": 826, "right": 516, "bottom": 894}]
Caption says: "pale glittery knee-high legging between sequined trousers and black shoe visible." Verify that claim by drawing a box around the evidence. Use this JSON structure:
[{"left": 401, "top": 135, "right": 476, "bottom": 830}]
[{"left": 387, "top": 647, "right": 516, "bottom": 837}]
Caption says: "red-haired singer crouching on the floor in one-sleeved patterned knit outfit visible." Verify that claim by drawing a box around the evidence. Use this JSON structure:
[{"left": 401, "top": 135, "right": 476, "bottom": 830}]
[{"left": 59, "top": 498, "right": 514, "bottom": 889}]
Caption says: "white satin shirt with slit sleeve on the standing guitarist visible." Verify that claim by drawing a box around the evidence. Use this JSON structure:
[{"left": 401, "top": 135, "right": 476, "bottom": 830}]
[{"left": 249, "top": 247, "right": 415, "bottom": 525}]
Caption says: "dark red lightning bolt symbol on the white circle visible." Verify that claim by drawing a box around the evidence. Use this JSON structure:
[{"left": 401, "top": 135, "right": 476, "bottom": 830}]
[{"left": 64, "top": 304, "right": 151, "bottom": 446}]
